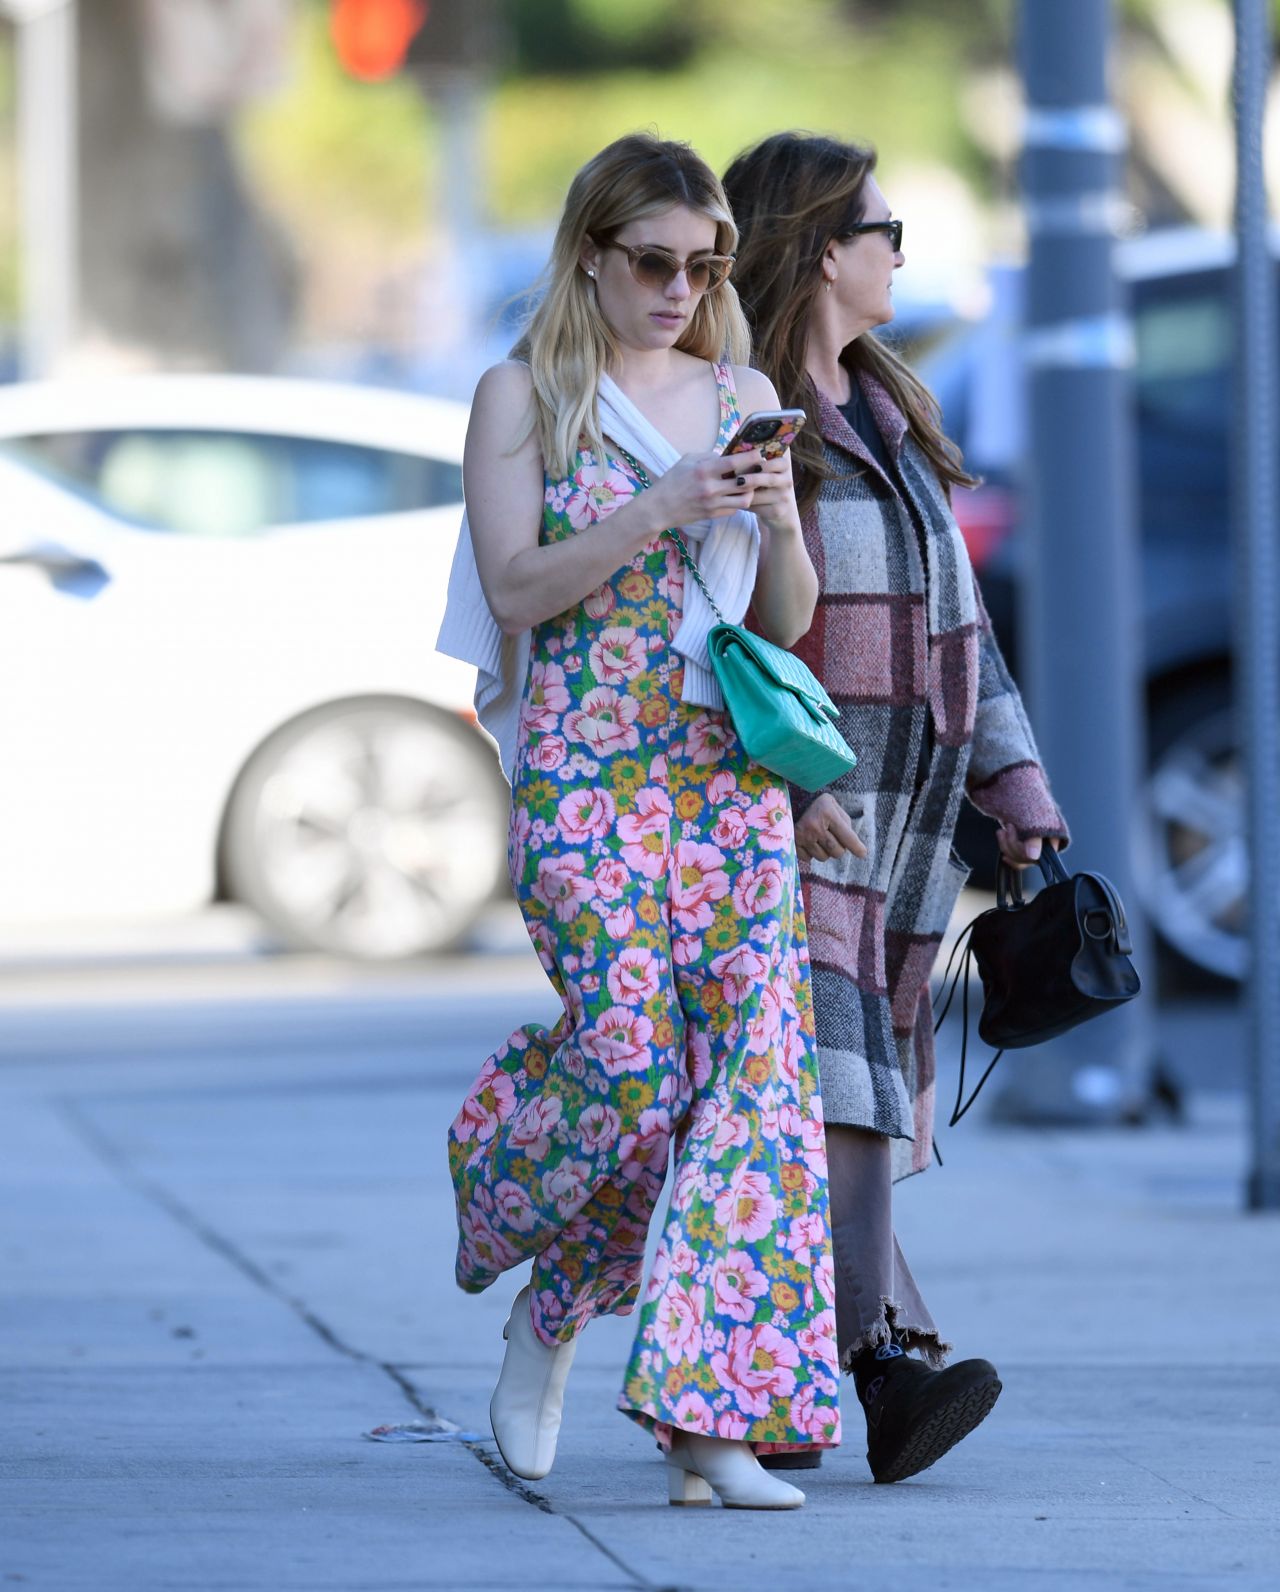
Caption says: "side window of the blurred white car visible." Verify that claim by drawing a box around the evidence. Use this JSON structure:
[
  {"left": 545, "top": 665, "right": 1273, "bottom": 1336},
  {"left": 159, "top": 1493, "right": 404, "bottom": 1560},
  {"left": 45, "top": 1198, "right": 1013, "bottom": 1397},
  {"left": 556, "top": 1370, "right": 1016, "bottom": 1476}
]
[{"left": 5, "top": 430, "right": 462, "bottom": 537}]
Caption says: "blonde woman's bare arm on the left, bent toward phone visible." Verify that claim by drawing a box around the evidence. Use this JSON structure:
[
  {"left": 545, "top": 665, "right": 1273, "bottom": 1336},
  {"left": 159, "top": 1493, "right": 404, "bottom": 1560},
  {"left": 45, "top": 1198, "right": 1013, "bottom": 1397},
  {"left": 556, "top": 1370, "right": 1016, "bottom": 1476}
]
[{"left": 462, "top": 360, "right": 770, "bottom": 635}]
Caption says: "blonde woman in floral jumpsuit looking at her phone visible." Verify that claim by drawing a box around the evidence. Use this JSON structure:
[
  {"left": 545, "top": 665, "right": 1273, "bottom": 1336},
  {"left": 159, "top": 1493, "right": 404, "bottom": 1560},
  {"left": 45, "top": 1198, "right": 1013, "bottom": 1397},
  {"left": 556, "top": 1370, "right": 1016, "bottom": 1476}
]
[{"left": 443, "top": 135, "right": 839, "bottom": 1509}]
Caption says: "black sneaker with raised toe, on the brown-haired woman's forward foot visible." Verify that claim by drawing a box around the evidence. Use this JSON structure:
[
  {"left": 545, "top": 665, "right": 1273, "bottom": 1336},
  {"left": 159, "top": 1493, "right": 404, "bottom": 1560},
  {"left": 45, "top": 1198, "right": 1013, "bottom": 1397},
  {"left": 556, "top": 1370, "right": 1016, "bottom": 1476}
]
[{"left": 855, "top": 1355, "right": 1000, "bottom": 1482}]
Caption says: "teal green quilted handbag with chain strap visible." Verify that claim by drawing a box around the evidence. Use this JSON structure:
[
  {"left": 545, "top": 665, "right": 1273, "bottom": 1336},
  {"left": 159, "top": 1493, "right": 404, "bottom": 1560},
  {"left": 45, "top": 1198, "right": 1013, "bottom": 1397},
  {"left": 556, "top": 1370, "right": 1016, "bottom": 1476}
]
[{"left": 619, "top": 449, "right": 858, "bottom": 791}]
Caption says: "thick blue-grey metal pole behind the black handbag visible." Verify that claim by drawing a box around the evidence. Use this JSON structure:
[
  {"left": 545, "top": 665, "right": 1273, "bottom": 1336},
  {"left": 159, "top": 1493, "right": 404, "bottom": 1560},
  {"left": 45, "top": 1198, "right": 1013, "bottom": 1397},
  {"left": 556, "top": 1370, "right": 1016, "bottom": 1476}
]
[{"left": 993, "top": 0, "right": 1153, "bottom": 1122}]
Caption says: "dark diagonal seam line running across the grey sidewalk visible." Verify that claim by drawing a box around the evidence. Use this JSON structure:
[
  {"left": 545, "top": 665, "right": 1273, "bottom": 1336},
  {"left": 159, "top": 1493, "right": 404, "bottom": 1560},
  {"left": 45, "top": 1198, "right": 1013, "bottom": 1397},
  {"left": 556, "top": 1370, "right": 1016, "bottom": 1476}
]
[{"left": 56, "top": 1095, "right": 661, "bottom": 1592}]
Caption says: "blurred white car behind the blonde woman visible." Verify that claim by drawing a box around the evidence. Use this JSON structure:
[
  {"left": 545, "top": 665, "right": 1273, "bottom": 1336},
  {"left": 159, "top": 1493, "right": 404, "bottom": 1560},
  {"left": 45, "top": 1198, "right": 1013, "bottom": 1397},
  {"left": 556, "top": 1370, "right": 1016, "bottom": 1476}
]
[{"left": 0, "top": 376, "right": 506, "bottom": 958}]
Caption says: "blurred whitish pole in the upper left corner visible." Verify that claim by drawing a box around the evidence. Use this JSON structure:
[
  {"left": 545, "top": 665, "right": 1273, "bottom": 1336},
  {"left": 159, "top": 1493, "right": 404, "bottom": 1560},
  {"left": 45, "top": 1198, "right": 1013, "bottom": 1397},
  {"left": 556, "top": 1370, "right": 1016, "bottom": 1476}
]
[{"left": 6, "top": 0, "right": 78, "bottom": 377}]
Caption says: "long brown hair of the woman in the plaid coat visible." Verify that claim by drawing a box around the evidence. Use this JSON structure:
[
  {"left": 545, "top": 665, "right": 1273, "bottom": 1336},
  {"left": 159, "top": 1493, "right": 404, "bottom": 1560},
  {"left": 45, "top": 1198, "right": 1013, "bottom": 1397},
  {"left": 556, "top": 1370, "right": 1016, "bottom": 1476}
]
[{"left": 724, "top": 132, "right": 976, "bottom": 509}]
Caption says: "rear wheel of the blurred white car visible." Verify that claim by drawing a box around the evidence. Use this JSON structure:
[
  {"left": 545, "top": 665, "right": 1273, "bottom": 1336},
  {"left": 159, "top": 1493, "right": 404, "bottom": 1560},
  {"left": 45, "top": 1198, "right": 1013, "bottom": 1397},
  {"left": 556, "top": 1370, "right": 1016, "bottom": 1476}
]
[{"left": 223, "top": 699, "right": 508, "bottom": 960}]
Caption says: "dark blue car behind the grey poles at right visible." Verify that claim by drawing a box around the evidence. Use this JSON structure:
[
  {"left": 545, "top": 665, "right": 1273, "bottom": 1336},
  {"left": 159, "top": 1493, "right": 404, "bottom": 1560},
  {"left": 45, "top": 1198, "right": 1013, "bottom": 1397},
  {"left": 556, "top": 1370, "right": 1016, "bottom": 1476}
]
[{"left": 920, "top": 229, "right": 1248, "bottom": 979}]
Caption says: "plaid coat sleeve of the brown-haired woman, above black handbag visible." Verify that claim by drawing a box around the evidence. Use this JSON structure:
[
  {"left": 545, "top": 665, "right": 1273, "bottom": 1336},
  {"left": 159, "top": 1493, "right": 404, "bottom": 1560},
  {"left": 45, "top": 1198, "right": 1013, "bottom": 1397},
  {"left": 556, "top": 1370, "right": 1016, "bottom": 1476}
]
[{"left": 966, "top": 579, "right": 1070, "bottom": 844}]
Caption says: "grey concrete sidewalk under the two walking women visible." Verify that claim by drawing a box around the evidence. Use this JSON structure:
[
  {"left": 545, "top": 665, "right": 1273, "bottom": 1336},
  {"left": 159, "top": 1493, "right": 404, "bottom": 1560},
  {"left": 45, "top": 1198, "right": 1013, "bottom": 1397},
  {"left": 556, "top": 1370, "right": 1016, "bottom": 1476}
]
[{"left": 0, "top": 992, "right": 1280, "bottom": 1592}]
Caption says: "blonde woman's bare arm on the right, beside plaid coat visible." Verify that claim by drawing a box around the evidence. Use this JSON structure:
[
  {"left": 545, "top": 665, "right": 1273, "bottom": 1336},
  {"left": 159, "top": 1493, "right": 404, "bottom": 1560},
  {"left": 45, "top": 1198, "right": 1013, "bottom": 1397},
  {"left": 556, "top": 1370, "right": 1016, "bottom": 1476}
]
[{"left": 734, "top": 365, "right": 818, "bottom": 646}]
